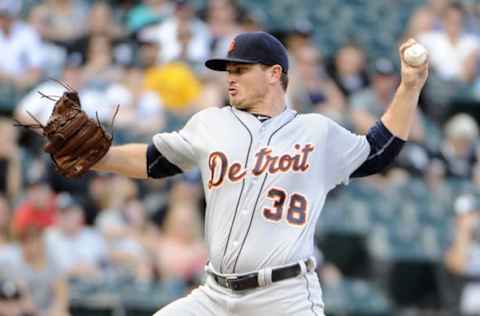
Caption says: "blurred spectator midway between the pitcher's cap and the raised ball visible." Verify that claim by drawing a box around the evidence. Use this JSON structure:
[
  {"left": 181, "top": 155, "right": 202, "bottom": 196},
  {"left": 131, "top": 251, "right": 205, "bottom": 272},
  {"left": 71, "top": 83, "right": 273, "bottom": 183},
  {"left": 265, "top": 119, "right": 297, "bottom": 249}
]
[{"left": 329, "top": 43, "right": 369, "bottom": 97}]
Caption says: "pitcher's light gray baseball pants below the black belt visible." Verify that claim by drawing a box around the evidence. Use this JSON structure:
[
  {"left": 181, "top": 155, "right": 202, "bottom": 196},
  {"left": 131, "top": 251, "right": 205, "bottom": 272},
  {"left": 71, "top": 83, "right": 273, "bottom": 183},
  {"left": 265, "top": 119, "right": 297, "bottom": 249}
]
[{"left": 154, "top": 262, "right": 325, "bottom": 316}]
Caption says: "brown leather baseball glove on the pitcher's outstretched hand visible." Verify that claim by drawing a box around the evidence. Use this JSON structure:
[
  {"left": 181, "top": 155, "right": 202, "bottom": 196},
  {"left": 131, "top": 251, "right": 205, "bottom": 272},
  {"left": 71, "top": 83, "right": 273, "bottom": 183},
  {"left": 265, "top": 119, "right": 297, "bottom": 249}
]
[{"left": 16, "top": 81, "right": 118, "bottom": 178}]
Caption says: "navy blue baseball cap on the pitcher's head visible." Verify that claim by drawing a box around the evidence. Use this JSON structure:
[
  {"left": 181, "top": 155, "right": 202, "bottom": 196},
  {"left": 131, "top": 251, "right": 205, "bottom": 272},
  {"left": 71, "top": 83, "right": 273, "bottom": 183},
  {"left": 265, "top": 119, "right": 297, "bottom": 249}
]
[{"left": 205, "top": 32, "right": 288, "bottom": 73}]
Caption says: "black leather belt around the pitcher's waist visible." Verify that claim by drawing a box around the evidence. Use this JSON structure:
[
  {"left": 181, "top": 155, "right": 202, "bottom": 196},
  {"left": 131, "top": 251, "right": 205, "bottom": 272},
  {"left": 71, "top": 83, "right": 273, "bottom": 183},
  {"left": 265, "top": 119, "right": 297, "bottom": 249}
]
[{"left": 210, "top": 263, "right": 308, "bottom": 291}]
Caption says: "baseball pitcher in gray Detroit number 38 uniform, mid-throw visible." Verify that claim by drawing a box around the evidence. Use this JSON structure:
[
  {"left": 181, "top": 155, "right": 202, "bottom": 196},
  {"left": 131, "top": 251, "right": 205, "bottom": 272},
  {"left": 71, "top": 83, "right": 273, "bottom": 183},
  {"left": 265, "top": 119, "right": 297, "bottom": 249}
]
[{"left": 94, "top": 32, "right": 428, "bottom": 316}]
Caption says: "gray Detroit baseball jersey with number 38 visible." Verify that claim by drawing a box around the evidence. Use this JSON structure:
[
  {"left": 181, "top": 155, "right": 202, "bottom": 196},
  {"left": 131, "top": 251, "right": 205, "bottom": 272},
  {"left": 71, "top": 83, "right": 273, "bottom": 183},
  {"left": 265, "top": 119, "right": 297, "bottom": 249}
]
[{"left": 153, "top": 107, "right": 370, "bottom": 274}]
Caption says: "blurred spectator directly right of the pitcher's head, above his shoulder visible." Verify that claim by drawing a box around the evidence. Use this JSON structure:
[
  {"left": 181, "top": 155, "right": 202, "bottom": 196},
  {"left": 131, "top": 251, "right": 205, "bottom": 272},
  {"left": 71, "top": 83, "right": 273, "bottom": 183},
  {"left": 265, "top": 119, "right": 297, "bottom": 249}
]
[{"left": 288, "top": 45, "right": 346, "bottom": 121}]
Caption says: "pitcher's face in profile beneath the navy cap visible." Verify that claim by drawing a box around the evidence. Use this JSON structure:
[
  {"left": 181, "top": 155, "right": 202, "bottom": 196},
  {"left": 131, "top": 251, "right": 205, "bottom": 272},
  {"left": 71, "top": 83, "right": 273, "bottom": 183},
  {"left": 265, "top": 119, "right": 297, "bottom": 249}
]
[{"left": 227, "top": 63, "right": 268, "bottom": 110}]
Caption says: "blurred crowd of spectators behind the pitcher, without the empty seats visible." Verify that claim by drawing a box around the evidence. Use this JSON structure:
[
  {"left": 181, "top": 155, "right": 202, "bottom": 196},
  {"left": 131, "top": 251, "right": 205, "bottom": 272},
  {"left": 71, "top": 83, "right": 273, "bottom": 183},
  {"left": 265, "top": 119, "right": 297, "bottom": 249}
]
[{"left": 0, "top": 0, "right": 480, "bottom": 316}]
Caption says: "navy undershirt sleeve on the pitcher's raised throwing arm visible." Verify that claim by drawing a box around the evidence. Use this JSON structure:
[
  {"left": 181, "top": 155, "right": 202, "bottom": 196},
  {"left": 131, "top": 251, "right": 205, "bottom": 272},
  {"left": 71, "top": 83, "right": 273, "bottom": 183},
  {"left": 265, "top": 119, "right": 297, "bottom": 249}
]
[{"left": 350, "top": 121, "right": 405, "bottom": 178}]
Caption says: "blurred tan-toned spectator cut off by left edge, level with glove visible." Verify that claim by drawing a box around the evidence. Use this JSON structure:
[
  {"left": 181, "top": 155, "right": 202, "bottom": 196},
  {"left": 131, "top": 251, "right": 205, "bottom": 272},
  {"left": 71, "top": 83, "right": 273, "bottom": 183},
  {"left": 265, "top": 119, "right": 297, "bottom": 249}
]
[{"left": 0, "top": 118, "right": 22, "bottom": 202}]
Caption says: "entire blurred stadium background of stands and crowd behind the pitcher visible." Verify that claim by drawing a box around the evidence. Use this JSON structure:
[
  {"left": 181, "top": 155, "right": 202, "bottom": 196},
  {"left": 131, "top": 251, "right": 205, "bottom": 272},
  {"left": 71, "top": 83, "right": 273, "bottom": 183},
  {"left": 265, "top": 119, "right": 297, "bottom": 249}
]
[{"left": 0, "top": 0, "right": 480, "bottom": 316}]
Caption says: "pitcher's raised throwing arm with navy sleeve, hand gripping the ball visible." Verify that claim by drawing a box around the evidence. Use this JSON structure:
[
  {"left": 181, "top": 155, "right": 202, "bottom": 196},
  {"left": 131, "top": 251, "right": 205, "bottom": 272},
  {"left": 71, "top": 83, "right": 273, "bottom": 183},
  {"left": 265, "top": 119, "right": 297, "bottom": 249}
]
[{"left": 351, "top": 40, "right": 428, "bottom": 177}]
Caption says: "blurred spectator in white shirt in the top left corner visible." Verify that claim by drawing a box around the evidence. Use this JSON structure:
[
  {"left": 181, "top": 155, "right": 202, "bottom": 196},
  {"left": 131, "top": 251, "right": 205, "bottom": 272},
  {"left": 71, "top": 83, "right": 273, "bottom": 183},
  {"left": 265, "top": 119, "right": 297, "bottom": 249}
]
[{"left": 0, "top": 0, "right": 43, "bottom": 111}]
